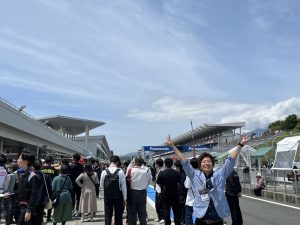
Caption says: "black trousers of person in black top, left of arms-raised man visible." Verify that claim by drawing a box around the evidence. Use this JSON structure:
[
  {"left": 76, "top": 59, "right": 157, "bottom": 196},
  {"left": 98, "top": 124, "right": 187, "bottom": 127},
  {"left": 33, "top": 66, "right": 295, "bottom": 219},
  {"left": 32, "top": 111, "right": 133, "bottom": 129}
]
[{"left": 162, "top": 195, "right": 181, "bottom": 225}]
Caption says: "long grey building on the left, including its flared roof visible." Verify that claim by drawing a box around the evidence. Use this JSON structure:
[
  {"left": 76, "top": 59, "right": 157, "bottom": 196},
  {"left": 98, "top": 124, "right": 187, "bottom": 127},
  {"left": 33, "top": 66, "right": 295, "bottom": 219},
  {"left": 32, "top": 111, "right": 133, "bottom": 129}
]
[{"left": 0, "top": 98, "right": 110, "bottom": 159}]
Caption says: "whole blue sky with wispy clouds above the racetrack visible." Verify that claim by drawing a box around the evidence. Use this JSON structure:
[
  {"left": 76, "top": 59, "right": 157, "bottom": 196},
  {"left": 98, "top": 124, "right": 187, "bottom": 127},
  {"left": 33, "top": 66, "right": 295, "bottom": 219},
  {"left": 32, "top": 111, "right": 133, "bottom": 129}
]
[{"left": 0, "top": 0, "right": 300, "bottom": 154}]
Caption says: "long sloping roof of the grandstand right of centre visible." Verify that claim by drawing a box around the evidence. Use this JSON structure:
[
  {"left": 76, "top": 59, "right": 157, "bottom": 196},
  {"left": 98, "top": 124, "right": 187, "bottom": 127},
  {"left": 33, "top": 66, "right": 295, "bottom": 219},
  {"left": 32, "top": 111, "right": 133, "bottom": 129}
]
[{"left": 172, "top": 122, "right": 245, "bottom": 144}]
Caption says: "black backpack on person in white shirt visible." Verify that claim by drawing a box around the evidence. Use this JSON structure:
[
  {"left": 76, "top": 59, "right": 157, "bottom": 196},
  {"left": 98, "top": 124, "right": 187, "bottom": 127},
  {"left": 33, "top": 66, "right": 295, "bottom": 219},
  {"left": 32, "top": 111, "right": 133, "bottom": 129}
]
[{"left": 104, "top": 169, "right": 121, "bottom": 199}]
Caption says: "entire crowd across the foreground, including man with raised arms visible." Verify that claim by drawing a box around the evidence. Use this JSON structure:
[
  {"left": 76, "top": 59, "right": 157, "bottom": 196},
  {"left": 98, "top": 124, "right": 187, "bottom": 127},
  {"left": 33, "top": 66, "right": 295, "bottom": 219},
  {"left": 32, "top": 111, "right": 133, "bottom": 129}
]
[{"left": 0, "top": 135, "right": 248, "bottom": 225}]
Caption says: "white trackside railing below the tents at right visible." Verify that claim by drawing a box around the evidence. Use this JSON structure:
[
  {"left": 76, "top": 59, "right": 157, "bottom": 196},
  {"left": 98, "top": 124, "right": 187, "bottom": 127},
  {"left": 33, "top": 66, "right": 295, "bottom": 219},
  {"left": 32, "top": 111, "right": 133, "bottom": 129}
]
[{"left": 238, "top": 167, "right": 300, "bottom": 194}]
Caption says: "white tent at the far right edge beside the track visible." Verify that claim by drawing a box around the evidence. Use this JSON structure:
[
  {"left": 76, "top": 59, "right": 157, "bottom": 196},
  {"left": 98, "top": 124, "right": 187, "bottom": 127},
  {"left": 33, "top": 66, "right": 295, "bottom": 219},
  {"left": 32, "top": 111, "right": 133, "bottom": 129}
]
[{"left": 272, "top": 136, "right": 300, "bottom": 170}]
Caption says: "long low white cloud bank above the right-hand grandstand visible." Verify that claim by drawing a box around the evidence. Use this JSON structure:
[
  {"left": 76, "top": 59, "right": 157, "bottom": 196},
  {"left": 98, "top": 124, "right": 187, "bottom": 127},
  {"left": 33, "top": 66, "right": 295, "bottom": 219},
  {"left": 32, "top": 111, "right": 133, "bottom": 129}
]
[{"left": 127, "top": 97, "right": 300, "bottom": 129}]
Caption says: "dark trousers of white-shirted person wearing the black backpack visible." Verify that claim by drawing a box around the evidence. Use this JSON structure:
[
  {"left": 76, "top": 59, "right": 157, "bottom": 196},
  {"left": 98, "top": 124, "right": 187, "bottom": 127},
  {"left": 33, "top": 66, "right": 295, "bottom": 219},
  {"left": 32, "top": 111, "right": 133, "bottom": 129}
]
[{"left": 104, "top": 195, "right": 124, "bottom": 225}]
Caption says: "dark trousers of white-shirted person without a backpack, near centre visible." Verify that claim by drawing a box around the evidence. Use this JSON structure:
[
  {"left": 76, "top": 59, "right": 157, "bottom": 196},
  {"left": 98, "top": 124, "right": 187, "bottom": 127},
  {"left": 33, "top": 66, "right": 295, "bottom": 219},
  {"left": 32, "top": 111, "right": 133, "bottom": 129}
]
[{"left": 128, "top": 189, "right": 147, "bottom": 225}]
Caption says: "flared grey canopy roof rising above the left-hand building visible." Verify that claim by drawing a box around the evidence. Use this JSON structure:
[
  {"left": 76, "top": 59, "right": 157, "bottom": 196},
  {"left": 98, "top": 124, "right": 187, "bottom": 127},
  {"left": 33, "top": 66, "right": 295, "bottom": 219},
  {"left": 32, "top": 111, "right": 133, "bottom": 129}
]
[{"left": 38, "top": 115, "right": 105, "bottom": 135}]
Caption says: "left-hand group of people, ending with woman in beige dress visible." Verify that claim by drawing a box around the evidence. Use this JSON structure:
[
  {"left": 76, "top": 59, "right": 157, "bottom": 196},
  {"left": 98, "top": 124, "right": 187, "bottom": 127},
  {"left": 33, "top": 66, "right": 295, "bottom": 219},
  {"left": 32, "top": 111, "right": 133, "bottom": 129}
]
[{"left": 0, "top": 151, "right": 102, "bottom": 225}]
